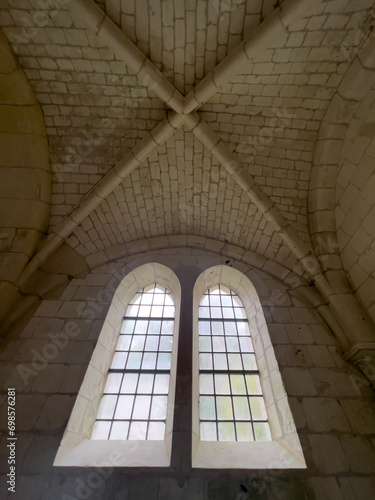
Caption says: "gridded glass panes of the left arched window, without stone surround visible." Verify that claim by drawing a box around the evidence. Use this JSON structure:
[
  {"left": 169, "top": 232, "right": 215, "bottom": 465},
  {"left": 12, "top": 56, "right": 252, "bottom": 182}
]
[{"left": 92, "top": 285, "right": 174, "bottom": 440}]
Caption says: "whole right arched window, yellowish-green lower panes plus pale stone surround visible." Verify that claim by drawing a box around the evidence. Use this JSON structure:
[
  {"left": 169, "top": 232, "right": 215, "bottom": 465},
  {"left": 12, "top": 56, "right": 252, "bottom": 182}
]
[{"left": 192, "top": 266, "right": 306, "bottom": 469}]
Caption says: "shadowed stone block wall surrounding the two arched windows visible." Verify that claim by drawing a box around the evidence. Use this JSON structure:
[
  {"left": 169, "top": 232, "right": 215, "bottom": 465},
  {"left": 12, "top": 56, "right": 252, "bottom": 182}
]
[{"left": 0, "top": 249, "right": 375, "bottom": 500}]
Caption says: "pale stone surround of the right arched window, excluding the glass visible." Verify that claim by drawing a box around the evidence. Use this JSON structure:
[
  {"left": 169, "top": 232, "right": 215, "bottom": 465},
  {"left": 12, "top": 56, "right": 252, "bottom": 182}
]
[{"left": 192, "top": 265, "right": 306, "bottom": 469}]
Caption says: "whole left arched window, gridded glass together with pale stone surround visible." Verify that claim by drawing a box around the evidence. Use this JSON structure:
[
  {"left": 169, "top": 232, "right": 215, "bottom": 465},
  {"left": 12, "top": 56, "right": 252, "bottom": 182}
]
[{"left": 54, "top": 263, "right": 181, "bottom": 467}]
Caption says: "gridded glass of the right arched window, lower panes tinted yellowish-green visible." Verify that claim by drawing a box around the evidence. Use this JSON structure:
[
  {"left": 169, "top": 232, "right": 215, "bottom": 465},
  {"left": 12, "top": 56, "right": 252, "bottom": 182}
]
[{"left": 198, "top": 285, "right": 271, "bottom": 441}]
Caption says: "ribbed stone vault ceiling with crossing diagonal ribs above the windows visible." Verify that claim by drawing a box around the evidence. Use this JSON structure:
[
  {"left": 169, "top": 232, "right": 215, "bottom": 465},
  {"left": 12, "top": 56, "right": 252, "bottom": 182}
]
[{"left": 0, "top": 0, "right": 373, "bottom": 328}]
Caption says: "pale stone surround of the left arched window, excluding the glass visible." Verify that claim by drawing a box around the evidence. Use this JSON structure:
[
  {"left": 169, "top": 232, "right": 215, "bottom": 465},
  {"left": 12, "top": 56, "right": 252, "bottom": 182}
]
[{"left": 53, "top": 262, "right": 181, "bottom": 467}]
